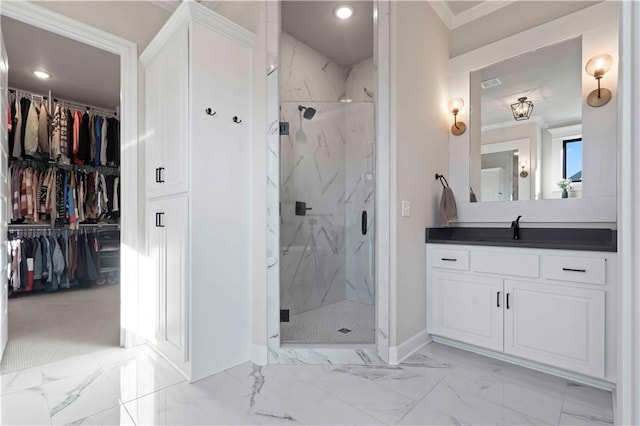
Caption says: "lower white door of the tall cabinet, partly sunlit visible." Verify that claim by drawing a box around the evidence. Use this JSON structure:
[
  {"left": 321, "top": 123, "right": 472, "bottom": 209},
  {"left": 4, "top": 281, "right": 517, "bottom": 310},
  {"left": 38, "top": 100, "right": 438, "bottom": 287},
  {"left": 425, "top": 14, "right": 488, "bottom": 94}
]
[{"left": 147, "top": 196, "right": 189, "bottom": 367}]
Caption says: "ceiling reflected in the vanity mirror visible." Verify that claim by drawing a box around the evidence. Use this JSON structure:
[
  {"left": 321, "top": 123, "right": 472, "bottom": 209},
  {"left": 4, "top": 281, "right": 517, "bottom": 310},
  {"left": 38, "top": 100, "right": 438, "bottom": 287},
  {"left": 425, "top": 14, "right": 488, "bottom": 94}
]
[{"left": 479, "top": 38, "right": 580, "bottom": 129}]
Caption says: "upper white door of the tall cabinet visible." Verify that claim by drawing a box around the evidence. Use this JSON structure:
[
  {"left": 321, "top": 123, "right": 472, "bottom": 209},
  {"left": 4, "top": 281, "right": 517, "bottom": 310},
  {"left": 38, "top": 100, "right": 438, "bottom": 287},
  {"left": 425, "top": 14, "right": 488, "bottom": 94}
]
[{"left": 145, "top": 26, "right": 189, "bottom": 198}]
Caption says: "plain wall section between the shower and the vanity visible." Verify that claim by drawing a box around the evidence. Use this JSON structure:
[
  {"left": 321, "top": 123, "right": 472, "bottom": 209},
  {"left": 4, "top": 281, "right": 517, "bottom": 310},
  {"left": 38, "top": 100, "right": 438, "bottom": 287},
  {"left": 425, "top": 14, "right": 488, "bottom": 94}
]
[{"left": 390, "top": 1, "right": 453, "bottom": 346}]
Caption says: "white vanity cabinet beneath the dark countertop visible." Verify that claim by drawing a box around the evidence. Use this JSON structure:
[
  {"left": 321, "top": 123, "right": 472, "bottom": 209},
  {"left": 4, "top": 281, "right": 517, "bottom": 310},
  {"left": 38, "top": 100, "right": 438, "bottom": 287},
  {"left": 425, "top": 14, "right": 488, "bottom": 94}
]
[{"left": 427, "top": 244, "right": 616, "bottom": 382}]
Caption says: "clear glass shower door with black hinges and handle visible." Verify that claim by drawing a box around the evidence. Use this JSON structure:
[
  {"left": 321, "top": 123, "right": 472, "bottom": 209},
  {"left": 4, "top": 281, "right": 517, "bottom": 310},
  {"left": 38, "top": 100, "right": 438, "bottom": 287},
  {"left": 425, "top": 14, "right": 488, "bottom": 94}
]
[{"left": 280, "top": 102, "right": 375, "bottom": 344}]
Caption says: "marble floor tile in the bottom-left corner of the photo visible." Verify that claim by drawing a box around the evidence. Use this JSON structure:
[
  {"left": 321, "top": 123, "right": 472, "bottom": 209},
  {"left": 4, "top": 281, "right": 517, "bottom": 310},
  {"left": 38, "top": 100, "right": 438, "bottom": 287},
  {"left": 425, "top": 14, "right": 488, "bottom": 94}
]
[{"left": 0, "top": 386, "right": 50, "bottom": 425}]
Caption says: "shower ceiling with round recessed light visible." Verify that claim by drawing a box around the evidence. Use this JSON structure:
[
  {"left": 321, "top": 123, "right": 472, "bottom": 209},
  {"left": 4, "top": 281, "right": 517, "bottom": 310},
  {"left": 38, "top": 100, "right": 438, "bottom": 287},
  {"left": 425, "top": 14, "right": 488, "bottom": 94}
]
[{"left": 281, "top": 1, "right": 373, "bottom": 68}]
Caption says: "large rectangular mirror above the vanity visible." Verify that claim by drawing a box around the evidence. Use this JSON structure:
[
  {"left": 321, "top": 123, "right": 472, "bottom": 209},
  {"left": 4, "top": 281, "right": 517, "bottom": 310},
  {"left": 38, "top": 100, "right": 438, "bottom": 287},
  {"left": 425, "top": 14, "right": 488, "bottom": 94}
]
[{"left": 469, "top": 37, "right": 583, "bottom": 202}]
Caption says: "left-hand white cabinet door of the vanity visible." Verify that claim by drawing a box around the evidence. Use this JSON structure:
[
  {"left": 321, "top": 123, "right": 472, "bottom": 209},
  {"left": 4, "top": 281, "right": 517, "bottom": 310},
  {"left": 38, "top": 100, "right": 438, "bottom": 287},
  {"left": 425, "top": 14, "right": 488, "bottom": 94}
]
[{"left": 429, "top": 270, "right": 503, "bottom": 351}]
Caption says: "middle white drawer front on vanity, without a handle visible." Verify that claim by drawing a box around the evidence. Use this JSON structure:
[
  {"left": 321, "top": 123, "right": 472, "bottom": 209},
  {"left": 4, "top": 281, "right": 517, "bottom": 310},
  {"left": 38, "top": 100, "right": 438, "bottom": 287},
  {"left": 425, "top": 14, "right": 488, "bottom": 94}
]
[{"left": 471, "top": 251, "right": 540, "bottom": 278}]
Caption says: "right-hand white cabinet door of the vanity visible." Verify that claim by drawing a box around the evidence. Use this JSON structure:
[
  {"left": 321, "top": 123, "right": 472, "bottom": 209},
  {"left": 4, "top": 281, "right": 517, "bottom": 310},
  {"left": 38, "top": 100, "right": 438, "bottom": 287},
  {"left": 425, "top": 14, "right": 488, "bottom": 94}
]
[{"left": 504, "top": 280, "right": 605, "bottom": 377}]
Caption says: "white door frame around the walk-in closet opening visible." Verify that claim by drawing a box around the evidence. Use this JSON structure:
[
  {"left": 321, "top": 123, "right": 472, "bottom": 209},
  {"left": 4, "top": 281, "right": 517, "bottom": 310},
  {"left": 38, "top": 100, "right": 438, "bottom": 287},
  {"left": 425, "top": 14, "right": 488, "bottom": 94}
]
[{"left": 0, "top": 1, "right": 141, "bottom": 347}]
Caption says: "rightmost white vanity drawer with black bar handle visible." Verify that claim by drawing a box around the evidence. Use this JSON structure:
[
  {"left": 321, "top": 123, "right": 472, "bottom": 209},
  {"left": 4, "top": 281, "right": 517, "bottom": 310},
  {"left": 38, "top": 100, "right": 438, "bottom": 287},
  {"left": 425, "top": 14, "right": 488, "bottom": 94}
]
[{"left": 542, "top": 256, "right": 607, "bottom": 285}]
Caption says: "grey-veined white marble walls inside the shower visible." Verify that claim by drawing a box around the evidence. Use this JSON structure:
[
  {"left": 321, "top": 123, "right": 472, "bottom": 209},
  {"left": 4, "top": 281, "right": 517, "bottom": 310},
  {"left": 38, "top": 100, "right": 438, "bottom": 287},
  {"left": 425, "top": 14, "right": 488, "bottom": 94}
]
[{"left": 279, "top": 32, "right": 375, "bottom": 314}]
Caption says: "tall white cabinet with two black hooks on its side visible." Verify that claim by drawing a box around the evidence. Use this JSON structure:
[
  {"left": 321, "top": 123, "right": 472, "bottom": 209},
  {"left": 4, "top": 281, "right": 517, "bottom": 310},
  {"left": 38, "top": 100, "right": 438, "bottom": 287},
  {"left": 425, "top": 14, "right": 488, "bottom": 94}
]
[{"left": 140, "top": 2, "right": 254, "bottom": 381}]
